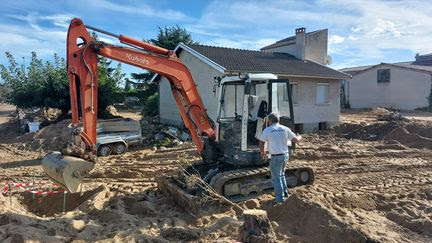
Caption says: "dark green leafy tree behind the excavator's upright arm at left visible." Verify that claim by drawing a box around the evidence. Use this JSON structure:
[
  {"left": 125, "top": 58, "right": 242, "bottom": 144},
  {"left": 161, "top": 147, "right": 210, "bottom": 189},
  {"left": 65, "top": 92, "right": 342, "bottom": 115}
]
[{"left": 0, "top": 52, "right": 125, "bottom": 117}]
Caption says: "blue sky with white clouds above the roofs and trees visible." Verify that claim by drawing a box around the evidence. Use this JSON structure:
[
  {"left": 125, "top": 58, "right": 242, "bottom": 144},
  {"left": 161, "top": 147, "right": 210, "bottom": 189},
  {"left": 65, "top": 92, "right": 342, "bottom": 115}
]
[{"left": 0, "top": 0, "right": 432, "bottom": 76}]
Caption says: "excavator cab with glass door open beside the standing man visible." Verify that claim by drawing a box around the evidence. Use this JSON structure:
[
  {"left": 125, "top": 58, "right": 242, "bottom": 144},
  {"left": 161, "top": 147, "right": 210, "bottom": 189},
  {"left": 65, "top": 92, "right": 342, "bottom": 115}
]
[{"left": 217, "top": 73, "right": 294, "bottom": 166}]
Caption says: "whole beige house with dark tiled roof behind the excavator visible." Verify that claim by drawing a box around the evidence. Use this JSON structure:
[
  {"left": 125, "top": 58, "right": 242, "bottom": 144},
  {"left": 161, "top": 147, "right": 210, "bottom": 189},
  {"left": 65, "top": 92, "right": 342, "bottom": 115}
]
[{"left": 159, "top": 28, "right": 349, "bottom": 132}]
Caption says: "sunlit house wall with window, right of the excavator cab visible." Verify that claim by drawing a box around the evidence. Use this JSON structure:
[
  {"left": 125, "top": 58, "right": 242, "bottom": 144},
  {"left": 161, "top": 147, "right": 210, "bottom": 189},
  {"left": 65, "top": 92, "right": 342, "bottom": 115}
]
[{"left": 279, "top": 76, "right": 340, "bottom": 132}]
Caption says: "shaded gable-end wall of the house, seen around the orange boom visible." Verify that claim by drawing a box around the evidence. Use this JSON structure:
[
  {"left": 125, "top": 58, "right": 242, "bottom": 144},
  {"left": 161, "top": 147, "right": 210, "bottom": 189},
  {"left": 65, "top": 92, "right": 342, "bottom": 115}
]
[{"left": 159, "top": 51, "right": 223, "bottom": 125}]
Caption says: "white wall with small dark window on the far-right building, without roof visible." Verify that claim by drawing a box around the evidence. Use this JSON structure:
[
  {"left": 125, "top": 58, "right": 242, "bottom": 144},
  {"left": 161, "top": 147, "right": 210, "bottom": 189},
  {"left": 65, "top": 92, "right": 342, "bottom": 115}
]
[{"left": 348, "top": 65, "right": 431, "bottom": 110}]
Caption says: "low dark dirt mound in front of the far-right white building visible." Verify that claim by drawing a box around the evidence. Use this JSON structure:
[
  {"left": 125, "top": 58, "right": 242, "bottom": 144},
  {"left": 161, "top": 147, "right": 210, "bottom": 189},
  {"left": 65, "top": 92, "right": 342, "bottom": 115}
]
[{"left": 334, "top": 121, "right": 432, "bottom": 149}]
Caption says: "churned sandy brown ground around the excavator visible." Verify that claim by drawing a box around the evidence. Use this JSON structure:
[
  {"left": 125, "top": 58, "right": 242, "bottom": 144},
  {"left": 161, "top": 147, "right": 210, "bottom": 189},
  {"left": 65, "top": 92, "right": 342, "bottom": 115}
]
[{"left": 0, "top": 105, "right": 432, "bottom": 242}]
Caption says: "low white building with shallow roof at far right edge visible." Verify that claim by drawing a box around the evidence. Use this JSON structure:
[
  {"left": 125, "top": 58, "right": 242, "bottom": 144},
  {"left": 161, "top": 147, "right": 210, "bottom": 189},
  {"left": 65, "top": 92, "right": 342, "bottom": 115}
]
[{"left": 340, "top": 54, "right": 432, "bottom": 110}]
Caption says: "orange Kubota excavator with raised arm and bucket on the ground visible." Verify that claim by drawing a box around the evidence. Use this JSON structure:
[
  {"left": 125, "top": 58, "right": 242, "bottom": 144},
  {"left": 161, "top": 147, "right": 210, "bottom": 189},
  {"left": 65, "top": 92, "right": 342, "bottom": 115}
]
[{"left": 42, "top": 19, "right": 314, "bottom": 209}]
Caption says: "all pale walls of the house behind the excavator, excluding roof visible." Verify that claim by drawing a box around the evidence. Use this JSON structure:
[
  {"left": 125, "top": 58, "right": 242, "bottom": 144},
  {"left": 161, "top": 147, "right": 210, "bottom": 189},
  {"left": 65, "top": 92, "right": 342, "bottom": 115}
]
[{"left": 159, "top": 51, "right": 340, "bottom": 132}]
